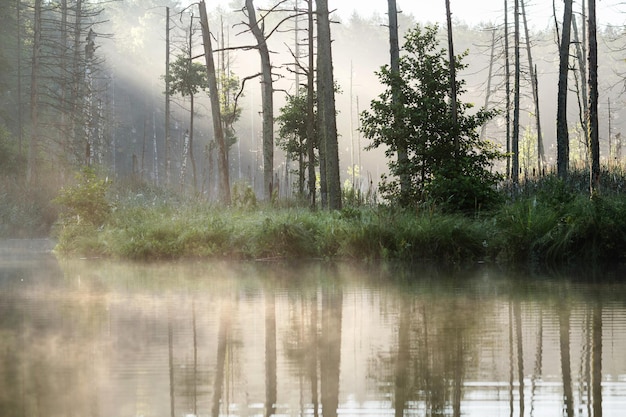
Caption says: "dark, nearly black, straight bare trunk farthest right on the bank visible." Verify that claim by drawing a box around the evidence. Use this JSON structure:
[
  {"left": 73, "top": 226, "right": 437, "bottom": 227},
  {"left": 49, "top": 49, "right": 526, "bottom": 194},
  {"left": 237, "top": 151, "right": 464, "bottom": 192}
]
[{"left": 588, "top": 0, "right": 600, "bottom": 196}]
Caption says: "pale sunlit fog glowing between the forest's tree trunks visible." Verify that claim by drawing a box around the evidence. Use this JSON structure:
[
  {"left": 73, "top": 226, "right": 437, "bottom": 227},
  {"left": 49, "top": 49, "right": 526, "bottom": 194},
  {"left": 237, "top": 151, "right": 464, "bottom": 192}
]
[{"left": 88, "top": 1, "right": 624, "bottom": 197}]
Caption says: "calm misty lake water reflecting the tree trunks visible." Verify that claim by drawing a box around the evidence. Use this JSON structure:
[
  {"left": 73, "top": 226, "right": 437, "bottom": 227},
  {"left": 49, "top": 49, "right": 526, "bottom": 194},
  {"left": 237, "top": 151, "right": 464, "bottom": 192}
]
[{"left": 0, "top": 241, "right": 626, "bottom": 417}]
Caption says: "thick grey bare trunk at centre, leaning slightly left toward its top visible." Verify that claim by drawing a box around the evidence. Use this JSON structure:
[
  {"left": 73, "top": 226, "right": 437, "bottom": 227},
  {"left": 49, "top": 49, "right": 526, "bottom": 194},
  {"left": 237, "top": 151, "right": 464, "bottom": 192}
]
[{"left": 317, "top": 0, "right": 341, "bottom": 210}]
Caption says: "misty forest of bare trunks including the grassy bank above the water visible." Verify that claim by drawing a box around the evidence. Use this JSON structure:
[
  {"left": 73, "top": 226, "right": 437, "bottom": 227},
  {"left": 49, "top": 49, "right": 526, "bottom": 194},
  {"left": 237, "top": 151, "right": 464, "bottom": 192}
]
[{"left": 0, "top": 0, "right": 626, "bottom": 260}]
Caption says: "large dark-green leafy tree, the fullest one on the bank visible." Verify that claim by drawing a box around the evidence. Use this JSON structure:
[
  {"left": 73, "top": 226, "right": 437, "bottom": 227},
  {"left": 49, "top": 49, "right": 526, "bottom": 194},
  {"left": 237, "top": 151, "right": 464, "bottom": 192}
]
[{"left": 361, "top": 25, "right": 503, "bottom": 211}]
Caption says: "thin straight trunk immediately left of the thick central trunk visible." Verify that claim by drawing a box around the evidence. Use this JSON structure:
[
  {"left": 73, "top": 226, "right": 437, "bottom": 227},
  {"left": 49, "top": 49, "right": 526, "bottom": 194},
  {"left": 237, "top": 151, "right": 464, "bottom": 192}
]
[{"left": 306, "top": 0, "right": 316, "bottom": 209}]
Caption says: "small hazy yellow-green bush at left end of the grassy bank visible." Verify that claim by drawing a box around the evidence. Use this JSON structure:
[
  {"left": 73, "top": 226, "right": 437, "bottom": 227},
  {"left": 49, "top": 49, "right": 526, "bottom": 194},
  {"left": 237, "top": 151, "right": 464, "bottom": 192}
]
[{"left": 54, "top": 167, "right": 112, "bottom": 226}]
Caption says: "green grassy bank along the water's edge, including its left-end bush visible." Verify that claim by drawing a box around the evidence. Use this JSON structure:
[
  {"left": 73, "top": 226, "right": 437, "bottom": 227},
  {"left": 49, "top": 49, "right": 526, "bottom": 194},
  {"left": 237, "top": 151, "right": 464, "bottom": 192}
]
[{"left": 50, "top": 167, "right": 626, "bottom": 264}]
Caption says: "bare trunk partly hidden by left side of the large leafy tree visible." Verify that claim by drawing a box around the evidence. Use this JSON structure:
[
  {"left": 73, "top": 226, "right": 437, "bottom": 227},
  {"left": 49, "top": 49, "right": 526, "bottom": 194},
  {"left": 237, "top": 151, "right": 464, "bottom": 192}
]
[{"left": 387, "top": 0, "right": 411, "bottom": 205}]
